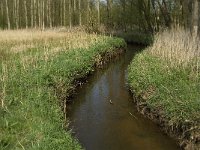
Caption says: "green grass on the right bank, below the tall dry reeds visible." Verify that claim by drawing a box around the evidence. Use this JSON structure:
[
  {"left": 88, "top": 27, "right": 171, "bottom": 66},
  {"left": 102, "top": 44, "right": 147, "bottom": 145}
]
[{"left": 128, "top": 50, "right": 200, "bottom": 144}]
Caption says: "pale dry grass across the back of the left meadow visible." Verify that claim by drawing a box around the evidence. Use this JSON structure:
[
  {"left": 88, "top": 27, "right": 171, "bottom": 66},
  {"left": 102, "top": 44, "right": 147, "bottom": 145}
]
[{"left": 0, "top": 29, "right": 105, "bottom": 64}]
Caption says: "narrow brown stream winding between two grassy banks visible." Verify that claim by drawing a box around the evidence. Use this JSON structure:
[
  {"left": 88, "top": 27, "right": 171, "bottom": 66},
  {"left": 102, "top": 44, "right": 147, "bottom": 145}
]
[{"left": 68, "top": 46, "right": 179, "bottom": 150}]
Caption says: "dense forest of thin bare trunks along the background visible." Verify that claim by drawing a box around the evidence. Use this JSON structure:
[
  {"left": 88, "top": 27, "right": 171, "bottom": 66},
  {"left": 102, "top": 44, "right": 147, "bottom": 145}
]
[{"left": 0, "top": 0, "right": 200, "bottom": 32}]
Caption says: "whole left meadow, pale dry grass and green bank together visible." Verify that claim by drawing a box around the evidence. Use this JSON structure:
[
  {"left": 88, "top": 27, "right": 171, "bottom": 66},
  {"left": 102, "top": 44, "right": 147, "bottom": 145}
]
[{"left": 0, "top": 30, "right": 125, "bottom": 150}]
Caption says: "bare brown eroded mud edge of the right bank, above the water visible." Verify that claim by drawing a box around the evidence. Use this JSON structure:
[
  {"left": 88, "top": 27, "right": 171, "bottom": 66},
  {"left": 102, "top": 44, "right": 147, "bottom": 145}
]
[{"left": 131, "top": 91, "right": 200, "bottom": 150}]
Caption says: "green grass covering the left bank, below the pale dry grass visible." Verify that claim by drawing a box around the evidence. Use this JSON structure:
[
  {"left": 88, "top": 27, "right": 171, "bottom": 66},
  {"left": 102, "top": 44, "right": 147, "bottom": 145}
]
[{"left": 0, "top": 34, "right": 125, "bottom": 150}]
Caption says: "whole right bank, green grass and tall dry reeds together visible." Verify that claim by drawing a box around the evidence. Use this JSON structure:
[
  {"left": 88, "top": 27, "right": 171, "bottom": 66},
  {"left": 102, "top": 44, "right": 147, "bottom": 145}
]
[{"left": 128, "top": 29, "right": 200, "bottom": 149}]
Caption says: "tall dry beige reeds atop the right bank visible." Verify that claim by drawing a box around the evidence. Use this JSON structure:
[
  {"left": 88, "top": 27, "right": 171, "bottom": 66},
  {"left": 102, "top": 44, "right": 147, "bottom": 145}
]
[{"left": 150, "top": 28, "right": 200, "bottom": 75}]
